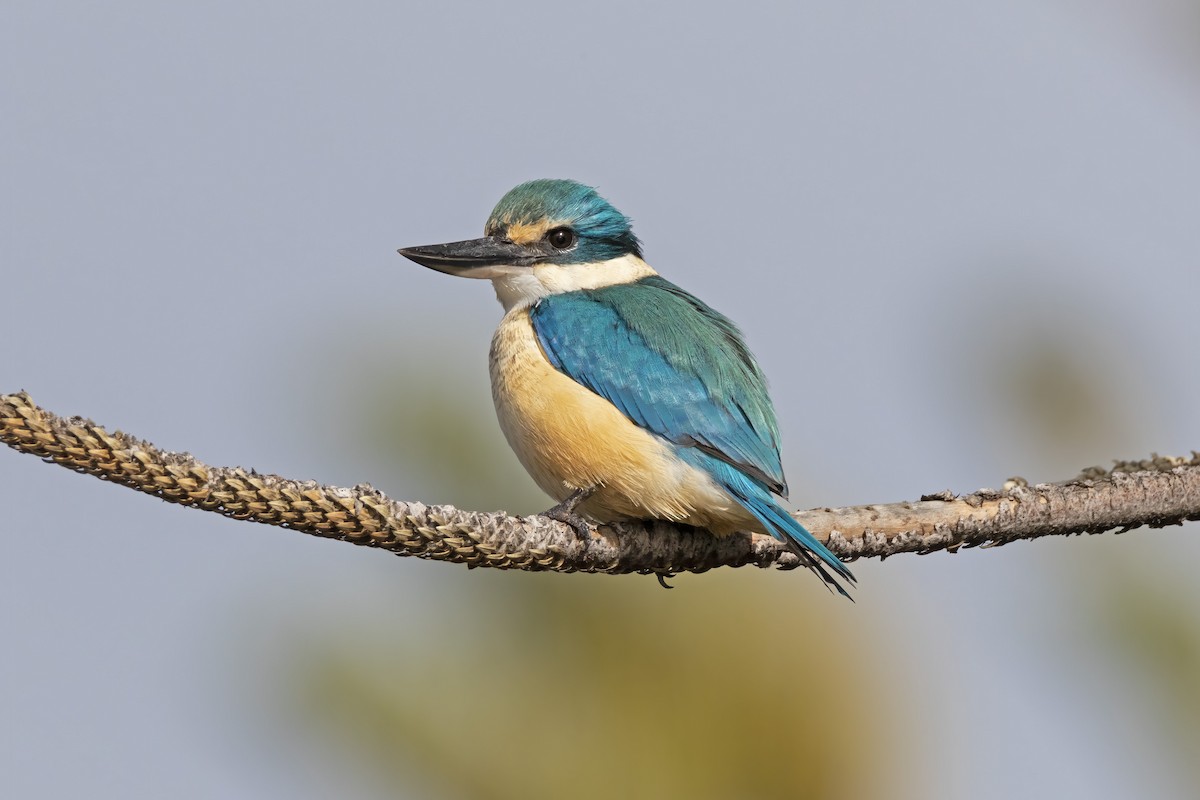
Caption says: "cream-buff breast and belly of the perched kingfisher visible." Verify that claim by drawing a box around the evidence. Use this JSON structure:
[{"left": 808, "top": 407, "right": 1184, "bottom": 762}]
[{"left": 491, "top": 306, "right": 761, "bottom": 534}]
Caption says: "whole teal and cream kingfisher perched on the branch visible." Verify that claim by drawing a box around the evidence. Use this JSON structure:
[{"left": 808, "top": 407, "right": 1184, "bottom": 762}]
[{"left": 400, "top": 179, "right": 854, "bottom": 597}]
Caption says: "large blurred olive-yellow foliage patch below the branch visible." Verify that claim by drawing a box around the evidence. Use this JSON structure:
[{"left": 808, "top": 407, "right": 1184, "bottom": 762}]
[{"left": 295, "top": 575, "right": 900, "bottom": 799}]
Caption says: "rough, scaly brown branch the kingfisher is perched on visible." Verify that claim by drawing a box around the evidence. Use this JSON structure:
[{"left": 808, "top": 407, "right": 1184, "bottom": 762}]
[{"left": 0, "top": 392, "right": 1200, "bottom": 575}]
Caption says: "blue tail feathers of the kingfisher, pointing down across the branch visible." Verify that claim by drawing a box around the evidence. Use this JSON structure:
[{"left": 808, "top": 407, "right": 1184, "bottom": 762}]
[{"left": 679, "top": 449, "right": 856, "bottom": 602}]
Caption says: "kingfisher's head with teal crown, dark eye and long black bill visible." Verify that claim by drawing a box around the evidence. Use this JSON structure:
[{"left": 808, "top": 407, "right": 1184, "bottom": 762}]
[{"left": 400, "top": 179, "right": 648, "bottom": 284}]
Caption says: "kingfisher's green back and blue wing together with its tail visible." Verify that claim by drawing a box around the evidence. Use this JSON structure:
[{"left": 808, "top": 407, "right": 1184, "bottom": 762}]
[{"left": 529, "top": 276, "right": 853, "bottom": 594}]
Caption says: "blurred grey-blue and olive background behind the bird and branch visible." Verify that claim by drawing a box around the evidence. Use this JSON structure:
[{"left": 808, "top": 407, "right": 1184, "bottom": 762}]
[{"left": 0, "top": 0, "right": 1200, "bottom": 799}]
